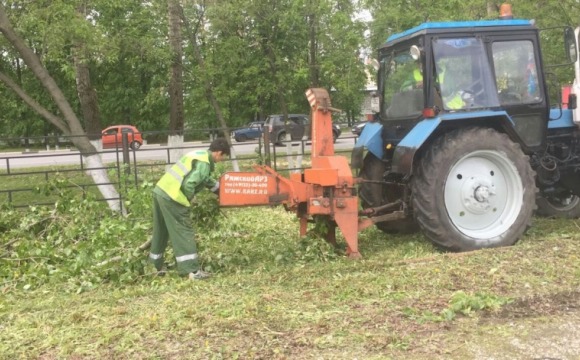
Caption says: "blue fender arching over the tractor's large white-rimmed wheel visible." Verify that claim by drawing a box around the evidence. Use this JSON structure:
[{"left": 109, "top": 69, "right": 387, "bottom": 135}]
[{"left": 392, "top": 111, "right": 524, "bottom": 177}]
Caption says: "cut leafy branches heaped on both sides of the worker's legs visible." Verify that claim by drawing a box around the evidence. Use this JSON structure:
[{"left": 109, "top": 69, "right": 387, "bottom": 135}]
[{"left": 0, "top": 177, "right": 337, "bottom": 292}]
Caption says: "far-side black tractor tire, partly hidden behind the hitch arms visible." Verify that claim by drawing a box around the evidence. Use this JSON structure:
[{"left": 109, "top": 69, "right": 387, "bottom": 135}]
[{"left": 358, "top": 152, "right": 419, "bottom": 234}]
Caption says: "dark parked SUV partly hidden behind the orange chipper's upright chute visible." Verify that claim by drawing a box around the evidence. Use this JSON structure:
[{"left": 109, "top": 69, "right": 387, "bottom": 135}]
[{"left": 265, "top": 114, "right": 342, "bottom": 145}]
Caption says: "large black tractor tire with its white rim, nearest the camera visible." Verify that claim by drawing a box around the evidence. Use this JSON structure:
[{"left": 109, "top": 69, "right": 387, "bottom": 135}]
[{"left": 411, "top": 128, "right": 537, "bottom": 251}]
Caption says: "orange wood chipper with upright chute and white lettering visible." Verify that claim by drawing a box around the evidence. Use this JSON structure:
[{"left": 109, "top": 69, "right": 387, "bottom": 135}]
[{"left": 220, "top": 89, "right": 374, "bottom": 258}]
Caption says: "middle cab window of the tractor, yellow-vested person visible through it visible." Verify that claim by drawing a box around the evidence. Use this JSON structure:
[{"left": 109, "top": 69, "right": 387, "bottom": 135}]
[{"left": 433, "top": 38, "right": 499, "bottom": 111}]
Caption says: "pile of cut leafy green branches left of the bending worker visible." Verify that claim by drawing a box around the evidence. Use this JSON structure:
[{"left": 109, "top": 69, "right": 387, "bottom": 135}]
[{"left": 0, "top": 179, "right": 150, "bottom": 292}]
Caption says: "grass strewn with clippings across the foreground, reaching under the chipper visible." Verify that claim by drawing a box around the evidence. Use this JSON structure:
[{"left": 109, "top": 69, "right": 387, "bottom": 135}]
[{"left": 0, "top": 202, "right": 580, "bottom": 359}]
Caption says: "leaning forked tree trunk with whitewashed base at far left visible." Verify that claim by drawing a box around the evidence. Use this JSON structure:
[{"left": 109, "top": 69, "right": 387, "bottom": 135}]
[{"left": 0, "top": 3, "right": 123, "bottom": 211}]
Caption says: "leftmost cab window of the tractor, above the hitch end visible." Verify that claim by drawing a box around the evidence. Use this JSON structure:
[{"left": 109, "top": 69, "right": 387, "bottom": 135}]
[{"left": 379, "top": 48, "right": 424, "bottom": 119}]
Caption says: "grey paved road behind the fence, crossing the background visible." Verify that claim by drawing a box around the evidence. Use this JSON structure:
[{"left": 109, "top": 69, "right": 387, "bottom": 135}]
[{"left": 0, "top": 134, "right": 355, "bottom": 170}]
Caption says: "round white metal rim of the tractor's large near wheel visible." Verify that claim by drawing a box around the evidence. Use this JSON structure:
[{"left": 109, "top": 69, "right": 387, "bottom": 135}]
[{"left": 444, "top": 150, "right": 524, "bottom": 239}]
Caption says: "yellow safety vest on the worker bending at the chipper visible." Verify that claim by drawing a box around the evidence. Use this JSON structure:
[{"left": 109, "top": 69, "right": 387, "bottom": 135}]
[{"left": 157, "top": 150, "right": 209, "bottom": 207}]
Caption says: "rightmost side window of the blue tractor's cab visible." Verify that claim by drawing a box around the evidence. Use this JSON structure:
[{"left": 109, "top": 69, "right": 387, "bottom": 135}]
[{"left": 492, "top": 40, "right": 542, "bottom": 105}]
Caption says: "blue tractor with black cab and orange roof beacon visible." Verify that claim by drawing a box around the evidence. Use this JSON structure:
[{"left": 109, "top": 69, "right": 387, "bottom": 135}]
[{"left": 352, "top": 7, "right": 580, "bottom": 251}]
